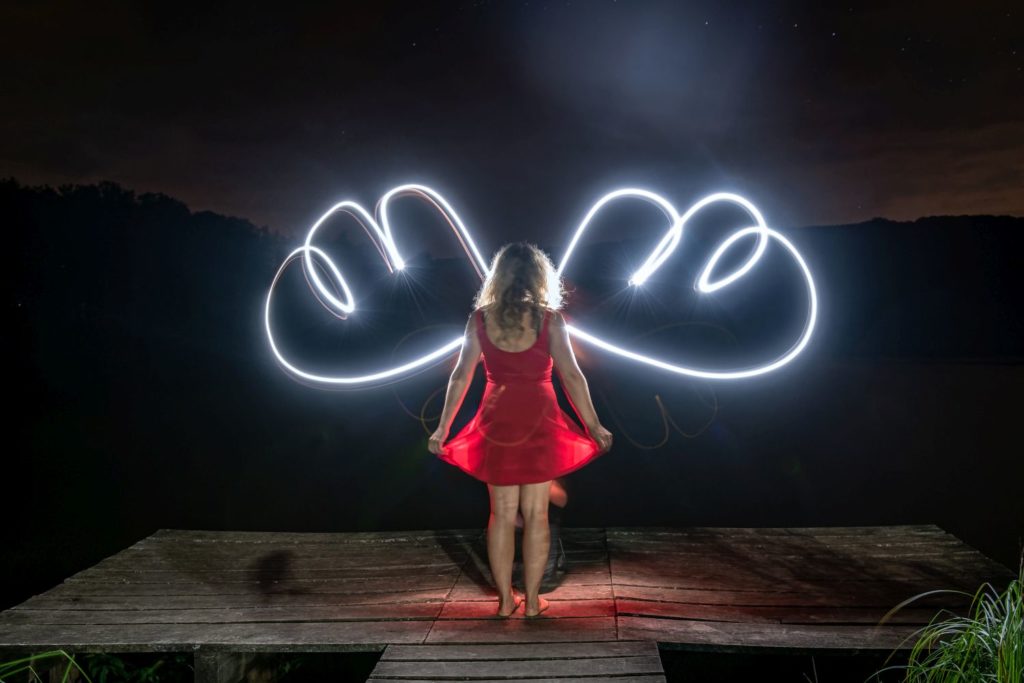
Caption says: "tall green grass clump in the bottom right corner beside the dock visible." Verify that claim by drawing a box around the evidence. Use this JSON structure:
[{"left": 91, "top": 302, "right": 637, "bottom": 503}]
[{"left": 869, "top": 553, "right": 1024, "bottom": 683}]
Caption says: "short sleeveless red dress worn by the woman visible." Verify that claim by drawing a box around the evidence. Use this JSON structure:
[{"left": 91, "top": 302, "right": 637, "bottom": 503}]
[{"left": 438, "top": 310, "right": 602, "bottom": 485}]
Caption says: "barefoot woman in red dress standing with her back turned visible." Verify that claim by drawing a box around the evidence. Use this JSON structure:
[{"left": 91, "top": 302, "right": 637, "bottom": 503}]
[{"left": 427, "top": 242, "right": 611, "bottom": 617}]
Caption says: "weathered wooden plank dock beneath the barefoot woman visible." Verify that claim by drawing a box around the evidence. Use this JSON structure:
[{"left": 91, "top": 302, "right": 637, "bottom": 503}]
[{"left": 0, "top": 525, "right": 1014, "bottom": 681}]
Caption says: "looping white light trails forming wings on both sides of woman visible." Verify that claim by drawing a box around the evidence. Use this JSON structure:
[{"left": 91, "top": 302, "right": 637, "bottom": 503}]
[{"left": 263, "top": 184, "right": 818, "bottom": 385}]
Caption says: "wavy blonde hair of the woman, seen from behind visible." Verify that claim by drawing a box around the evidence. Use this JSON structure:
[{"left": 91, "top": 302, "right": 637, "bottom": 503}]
[{"left": 473, "top": 242, "right": 565, "bottom": 337}]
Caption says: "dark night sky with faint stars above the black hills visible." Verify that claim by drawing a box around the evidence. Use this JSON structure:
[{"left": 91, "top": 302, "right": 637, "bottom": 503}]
[{"left": 0, "top": 0, "right": 1024, "bottom": 240}]
